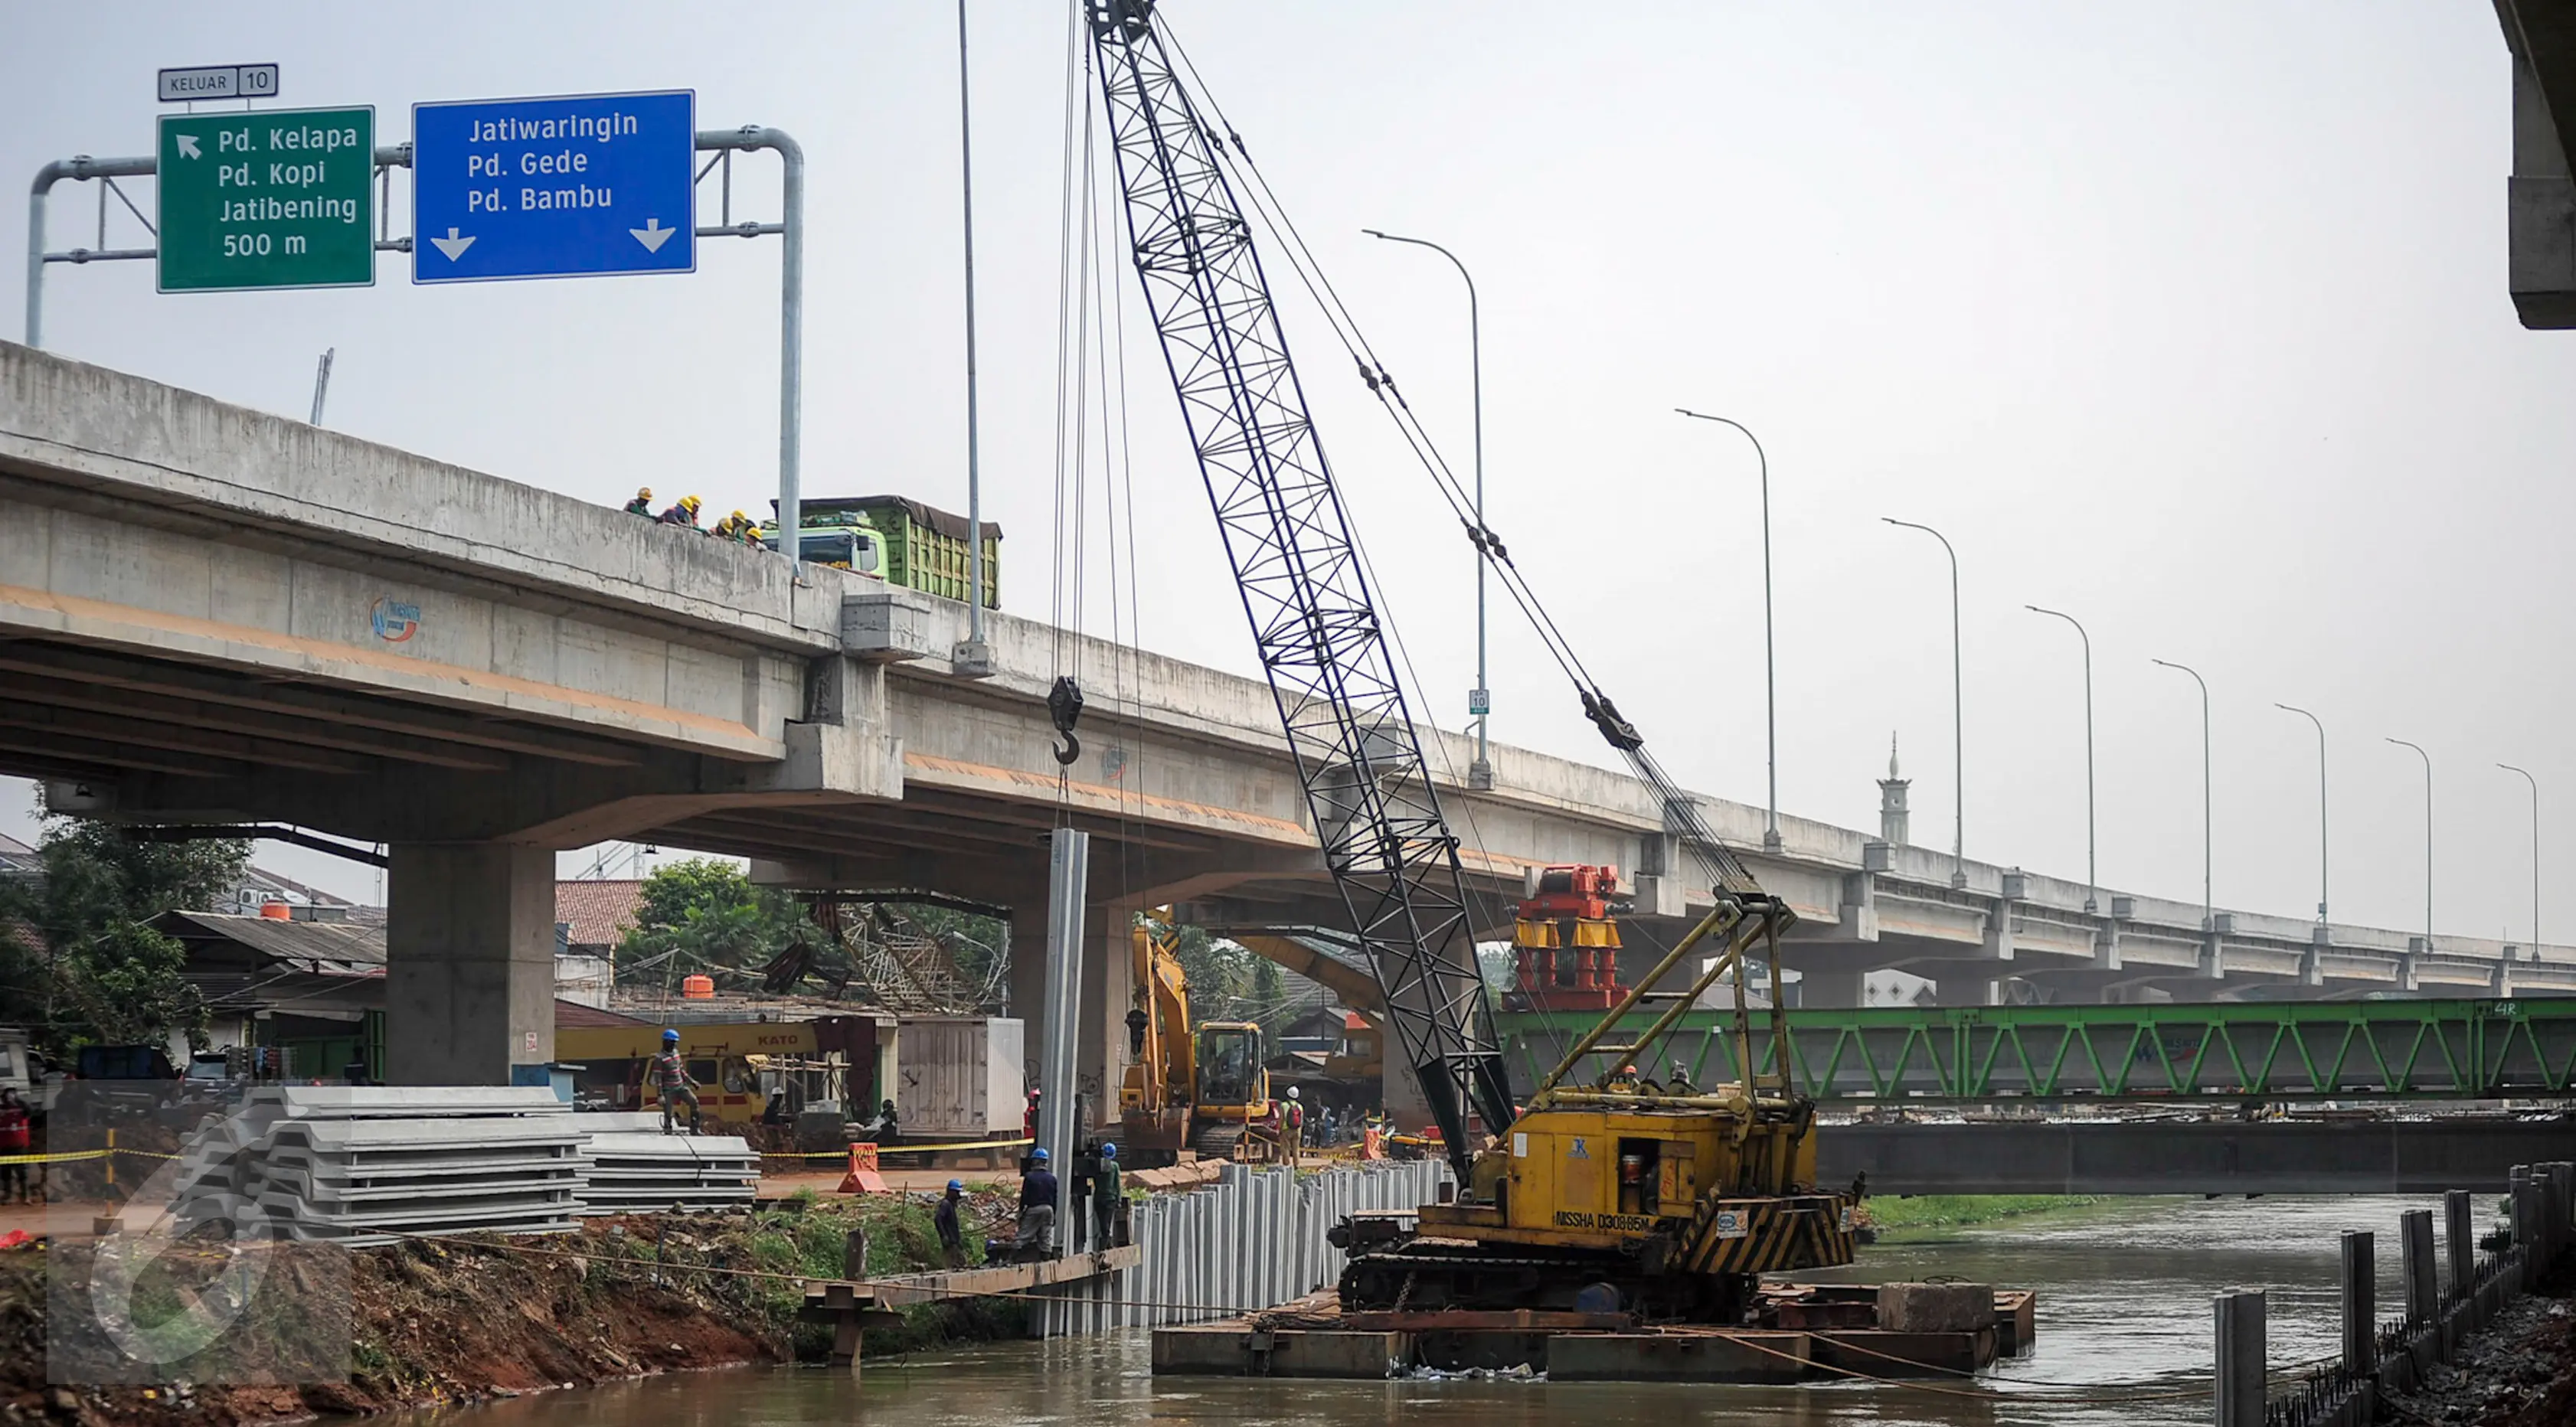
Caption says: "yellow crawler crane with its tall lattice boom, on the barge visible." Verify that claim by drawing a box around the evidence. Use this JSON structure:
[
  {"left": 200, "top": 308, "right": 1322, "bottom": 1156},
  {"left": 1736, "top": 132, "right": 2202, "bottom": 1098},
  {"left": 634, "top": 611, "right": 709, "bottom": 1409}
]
[{"left": 1084, "top": 0, "right": 1852, "bottom": 1321}]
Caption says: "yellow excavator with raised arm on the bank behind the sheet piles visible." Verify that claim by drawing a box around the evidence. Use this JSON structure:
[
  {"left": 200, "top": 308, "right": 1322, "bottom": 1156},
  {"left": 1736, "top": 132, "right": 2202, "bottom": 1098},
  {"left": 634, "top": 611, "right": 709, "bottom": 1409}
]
[{"left": 1118, "top": 919, "right": 1280, "bottom": 1170}]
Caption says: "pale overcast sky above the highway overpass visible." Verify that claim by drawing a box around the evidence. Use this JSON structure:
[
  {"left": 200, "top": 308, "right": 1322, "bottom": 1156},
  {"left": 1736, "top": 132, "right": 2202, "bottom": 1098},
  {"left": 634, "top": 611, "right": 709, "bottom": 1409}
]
[{"left": 0, "top": 0, "right": 2576, "bottom": 940}]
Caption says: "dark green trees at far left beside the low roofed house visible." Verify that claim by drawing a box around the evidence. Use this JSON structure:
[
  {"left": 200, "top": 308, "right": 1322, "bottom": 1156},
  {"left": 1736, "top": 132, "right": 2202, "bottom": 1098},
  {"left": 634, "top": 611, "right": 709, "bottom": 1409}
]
[{"left": 0, "top": 817, "right": 250, "bottom": 1056}]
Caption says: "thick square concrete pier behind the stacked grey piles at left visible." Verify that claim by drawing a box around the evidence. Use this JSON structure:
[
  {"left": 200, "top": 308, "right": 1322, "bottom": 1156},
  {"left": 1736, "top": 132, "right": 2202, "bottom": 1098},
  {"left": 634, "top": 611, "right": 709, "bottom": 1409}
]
[{"left": 384, "top": 842, "right": 554, "bottom": 1085}]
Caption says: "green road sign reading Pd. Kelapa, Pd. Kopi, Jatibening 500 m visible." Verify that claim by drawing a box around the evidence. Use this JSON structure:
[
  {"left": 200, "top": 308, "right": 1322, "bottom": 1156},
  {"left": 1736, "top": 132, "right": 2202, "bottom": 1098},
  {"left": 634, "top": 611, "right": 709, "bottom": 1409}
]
[{"left": 160, "top": 106, "right": 376, "bottom": 291}]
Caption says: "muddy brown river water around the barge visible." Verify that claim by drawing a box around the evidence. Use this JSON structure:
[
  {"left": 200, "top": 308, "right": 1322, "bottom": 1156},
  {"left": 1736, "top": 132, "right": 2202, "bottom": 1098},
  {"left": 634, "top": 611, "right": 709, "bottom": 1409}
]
[{"left": 407, "top": 1198, "right": 2452, "bottom": 1427}]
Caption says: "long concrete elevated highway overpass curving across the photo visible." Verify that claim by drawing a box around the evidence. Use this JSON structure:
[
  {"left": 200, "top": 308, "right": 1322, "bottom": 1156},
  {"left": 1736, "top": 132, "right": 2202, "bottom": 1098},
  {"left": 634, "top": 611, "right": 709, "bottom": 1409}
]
[{"left": 0, "top": 342, "right": 2576, "bottom": 1085}]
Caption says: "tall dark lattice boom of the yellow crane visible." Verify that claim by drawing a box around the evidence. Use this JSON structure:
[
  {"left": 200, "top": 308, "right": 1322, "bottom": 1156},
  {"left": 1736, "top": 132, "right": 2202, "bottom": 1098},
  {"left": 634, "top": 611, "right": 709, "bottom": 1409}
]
[{"left": 1087, "top": 0, "right": 1512, "bottom": 1164}]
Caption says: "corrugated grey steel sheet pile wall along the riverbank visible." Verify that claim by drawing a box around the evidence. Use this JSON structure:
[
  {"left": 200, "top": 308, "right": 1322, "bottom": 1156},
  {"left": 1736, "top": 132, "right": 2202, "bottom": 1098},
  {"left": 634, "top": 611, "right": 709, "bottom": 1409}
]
[{"left": 1038, "top": 1161, "right": 1450, "bottom": 1337}]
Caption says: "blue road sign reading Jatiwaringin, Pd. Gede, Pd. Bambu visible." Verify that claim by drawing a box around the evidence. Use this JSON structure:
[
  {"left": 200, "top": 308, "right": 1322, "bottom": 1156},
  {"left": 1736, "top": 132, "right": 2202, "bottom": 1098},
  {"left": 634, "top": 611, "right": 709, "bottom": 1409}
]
[{"left": 412, "top": 90, "right": 698, "bottom": 283}]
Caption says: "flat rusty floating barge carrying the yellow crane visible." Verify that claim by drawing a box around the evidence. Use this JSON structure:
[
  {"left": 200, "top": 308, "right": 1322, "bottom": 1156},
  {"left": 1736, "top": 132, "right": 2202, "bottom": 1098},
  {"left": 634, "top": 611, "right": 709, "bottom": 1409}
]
[{"left": 1154, "top": 1283, "right": 2038, "bottom": 1383}]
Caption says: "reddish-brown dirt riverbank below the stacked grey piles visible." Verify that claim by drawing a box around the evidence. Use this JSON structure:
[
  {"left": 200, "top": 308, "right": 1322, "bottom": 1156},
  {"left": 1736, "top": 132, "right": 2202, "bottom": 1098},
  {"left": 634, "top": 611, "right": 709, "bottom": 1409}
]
[{"left": 0, "top": 1195, "right": 1020, "bottom": 1427}]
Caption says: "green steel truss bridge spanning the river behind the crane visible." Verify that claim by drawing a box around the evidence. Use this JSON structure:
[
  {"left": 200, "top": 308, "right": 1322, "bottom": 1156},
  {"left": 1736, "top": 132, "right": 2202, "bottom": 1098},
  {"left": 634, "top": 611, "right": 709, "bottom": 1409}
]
[{"left": 1496, "top": 999, "right": 2576, "bottom": 1108}]
